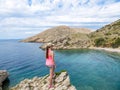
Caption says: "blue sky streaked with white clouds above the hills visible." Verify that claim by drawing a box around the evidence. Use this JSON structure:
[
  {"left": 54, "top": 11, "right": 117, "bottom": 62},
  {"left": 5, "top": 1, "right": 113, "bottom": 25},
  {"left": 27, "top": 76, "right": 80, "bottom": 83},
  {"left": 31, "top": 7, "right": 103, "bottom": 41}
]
[{"left": 0, "top": 0, "right": 120, "bottom": 39}]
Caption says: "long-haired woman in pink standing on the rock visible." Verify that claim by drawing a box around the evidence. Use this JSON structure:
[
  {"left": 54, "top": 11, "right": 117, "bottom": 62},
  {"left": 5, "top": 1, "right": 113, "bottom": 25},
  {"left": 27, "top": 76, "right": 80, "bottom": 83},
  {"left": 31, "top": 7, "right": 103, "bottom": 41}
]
[{"left": 46, "top": 44, "right": 55, "bottom": 88}]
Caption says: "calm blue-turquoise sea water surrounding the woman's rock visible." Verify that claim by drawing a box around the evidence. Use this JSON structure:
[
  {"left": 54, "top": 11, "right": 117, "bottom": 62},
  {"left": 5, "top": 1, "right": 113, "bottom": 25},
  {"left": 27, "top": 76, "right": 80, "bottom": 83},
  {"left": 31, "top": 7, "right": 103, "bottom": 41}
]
[{"left": 0, "top": 40, "right": 120, "bottom": 90}]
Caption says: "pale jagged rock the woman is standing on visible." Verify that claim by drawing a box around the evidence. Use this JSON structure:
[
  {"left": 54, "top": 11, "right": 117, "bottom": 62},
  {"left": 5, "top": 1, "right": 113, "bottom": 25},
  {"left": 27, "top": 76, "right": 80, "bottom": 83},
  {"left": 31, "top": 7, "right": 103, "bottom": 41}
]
[{"left": 10, "top": 71, "right": 76, "bottom": 90}]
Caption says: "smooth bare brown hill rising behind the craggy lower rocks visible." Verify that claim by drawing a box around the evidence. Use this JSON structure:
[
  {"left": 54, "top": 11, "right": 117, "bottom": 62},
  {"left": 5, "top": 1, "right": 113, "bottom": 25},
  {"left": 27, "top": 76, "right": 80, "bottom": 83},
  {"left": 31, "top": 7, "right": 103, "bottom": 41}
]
[{"left": 22, "top": 26, "right": 90, "bottom": 42}]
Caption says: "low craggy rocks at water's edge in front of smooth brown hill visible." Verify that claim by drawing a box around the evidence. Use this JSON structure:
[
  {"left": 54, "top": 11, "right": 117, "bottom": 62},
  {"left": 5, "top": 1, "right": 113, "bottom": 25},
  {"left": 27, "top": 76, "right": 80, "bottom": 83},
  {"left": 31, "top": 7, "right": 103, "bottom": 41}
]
[{"left": 40, "top": 33, "right": 91, "bottom": 49}]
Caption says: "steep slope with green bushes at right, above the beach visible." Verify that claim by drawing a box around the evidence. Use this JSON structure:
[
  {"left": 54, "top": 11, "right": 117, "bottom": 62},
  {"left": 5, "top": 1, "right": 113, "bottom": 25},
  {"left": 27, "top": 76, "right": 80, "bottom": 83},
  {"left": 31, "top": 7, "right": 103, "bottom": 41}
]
[{"left": 90, "top": 19, "right": 120, "bottom": 48}]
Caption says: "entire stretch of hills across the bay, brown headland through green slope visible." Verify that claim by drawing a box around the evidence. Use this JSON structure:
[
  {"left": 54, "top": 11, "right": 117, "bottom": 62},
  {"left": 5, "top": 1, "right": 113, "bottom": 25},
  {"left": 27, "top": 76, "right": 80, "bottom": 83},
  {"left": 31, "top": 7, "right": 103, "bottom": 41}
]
[{"left": 22, "top": 19, "right": 120, "bottom": 49}]
